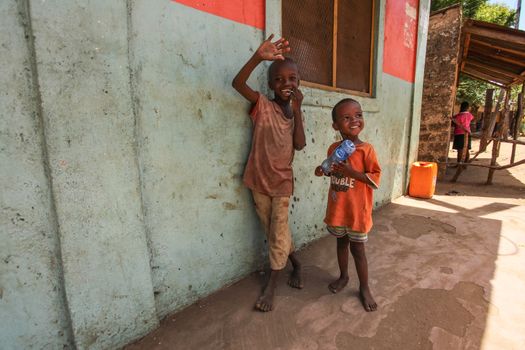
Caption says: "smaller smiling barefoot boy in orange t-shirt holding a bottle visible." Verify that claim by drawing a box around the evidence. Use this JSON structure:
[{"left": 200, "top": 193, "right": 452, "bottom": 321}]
[{"left": 315, "top": 98, "right": 381, "bottom": 311}]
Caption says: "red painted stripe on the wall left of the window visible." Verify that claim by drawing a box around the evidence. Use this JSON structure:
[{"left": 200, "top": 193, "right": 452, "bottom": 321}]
[{"left": 172, "top": 0, "right": 265, "bottom": 29}]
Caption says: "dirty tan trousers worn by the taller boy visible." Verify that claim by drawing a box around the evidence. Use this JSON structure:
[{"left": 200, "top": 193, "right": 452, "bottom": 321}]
[{"left": 252, "top": 191, "right": 295, "bottom": 270}]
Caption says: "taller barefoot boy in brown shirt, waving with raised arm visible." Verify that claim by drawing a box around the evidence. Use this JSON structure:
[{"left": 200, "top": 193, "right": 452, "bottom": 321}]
[{"left": 232, "top": 34, "right": 306, "bottom": 311}]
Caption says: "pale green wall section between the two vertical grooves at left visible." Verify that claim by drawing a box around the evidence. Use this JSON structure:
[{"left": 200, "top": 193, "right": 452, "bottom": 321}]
[{"left": 27, "top": 1, "right": 157, "bottom": 347}]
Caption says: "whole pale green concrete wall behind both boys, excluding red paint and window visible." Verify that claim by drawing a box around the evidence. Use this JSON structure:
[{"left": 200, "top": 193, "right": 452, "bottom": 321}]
[{"left": 0, "top": 0, "right": 429, "bottom": 349}]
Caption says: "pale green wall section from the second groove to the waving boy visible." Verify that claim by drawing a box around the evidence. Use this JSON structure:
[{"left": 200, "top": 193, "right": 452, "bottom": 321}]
[{"left": 131, "top": 0, "right": 270, "bottom": 316}]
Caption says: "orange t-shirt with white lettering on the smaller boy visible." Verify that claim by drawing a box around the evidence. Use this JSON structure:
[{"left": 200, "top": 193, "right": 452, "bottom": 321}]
[{"left": 324, "top": 142, "right": 381, "bottom": 233}]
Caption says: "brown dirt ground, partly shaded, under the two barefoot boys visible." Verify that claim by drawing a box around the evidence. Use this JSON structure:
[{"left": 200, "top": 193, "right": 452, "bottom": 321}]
[{"left": 126, "top": 138, "right": 525, "bottom": 350}]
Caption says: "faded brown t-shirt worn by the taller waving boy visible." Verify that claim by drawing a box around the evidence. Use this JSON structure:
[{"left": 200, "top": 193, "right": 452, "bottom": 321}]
[{"left": 243, "top": 94, "right": 294, "bottom": 197}]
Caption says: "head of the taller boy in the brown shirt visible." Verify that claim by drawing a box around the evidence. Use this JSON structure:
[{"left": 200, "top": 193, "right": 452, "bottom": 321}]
[{"left": 268, "top": 61, "right": 299, "bottom": 101}]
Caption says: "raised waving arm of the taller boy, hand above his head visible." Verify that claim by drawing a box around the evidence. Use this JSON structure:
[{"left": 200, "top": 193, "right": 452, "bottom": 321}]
[{"left": 232, "top": 34, "right": 290, "bottom": 103}]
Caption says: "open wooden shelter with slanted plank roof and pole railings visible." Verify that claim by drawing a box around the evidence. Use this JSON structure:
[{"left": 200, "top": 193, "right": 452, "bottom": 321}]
[{"left": 452, "top": 19, "right": 525, "bottom": 184}]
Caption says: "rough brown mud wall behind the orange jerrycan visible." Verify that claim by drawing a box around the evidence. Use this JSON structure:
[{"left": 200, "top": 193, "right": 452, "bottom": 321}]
[{"left": 418, "top": 6, "right": 461, "bottom": 177}]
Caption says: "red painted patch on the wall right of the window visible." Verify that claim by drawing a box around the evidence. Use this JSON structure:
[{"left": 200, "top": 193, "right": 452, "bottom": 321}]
[{"left": 383, "top": 0, "right": 419, "bottom": 83}]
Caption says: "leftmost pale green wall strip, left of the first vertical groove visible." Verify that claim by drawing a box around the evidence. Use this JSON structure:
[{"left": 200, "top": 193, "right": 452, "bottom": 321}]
[{"left": 0, "top": 0, "right": 70, "bottom": 349}]
